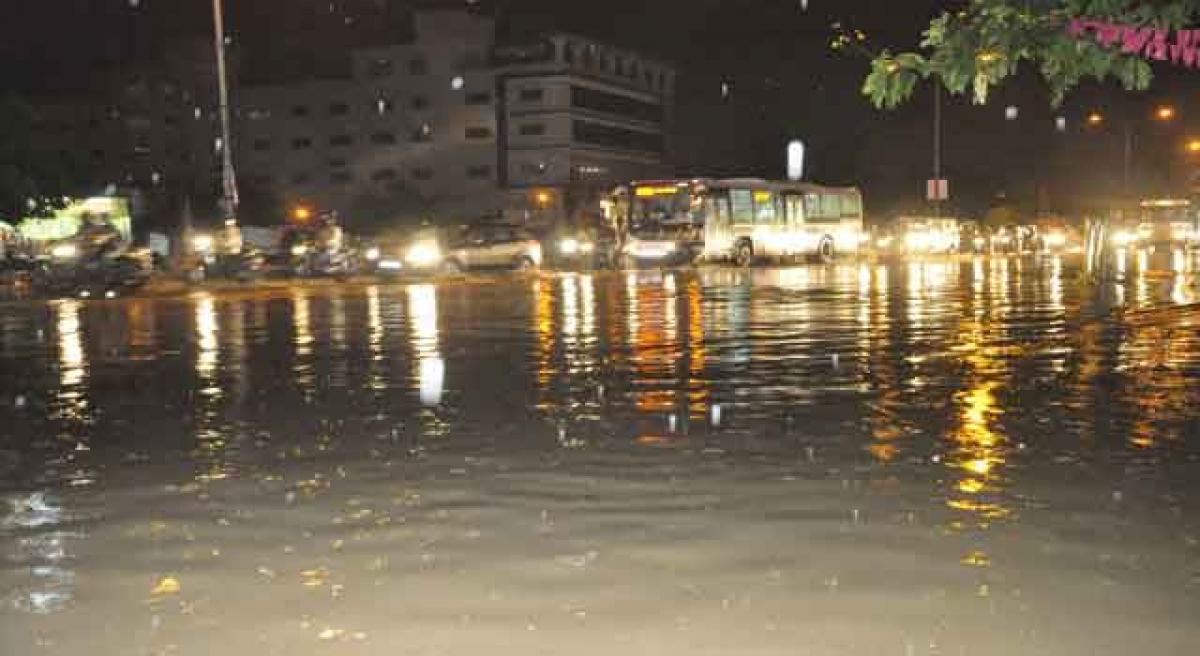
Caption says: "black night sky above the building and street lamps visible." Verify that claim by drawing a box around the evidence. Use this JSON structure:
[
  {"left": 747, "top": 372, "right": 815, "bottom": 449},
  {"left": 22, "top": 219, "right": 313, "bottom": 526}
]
[{"left": 0, "top": 0, "right": 1200, "bottom": 213}]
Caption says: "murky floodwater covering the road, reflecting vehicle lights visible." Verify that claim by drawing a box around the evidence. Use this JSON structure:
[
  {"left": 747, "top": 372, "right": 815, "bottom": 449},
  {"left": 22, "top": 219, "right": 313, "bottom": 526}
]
[{"left": 0, "top": 258, "right": 1200, "bottom": 656}]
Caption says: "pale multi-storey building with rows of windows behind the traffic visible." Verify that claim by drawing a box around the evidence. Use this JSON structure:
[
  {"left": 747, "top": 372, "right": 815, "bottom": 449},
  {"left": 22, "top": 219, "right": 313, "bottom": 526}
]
[{"left": 235, "top": 11, "right": 674, "bottom": 228}]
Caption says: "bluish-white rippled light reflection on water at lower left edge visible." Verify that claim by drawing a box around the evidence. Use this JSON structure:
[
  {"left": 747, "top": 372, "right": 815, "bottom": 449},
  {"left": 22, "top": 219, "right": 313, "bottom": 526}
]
[{"left": 0, "top": 492, "right": 80, "bottom": 614}]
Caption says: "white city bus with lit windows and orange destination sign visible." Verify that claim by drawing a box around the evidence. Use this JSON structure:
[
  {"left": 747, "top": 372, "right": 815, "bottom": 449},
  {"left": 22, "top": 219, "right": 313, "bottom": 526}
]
[{"left": 610, "top": 179, "right": 864, "bottom": 266}]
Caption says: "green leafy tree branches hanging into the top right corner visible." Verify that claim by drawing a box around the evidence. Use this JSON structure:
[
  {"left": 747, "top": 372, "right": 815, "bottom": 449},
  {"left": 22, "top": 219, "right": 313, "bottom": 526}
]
[{"left": 854, "top": 0, "right": 1200, "bottom": 109}]
